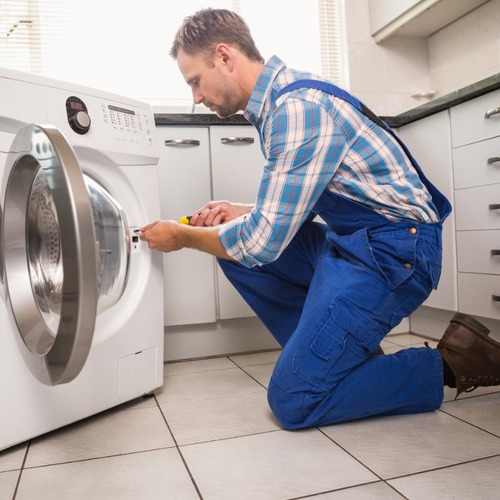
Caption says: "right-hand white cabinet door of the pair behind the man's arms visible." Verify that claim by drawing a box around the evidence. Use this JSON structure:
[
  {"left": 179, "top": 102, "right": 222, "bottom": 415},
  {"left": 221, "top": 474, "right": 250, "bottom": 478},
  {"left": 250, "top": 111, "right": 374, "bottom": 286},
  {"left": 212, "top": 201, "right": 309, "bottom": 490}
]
[{"left": 210, "top": 125, "right": 264, "bottom": 319}]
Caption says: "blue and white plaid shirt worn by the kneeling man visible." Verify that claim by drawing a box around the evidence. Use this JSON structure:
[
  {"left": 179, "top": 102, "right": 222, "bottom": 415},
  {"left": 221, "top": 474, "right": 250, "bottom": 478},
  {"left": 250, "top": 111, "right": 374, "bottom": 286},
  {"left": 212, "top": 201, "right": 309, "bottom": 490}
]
[{"left": 219, "top": 56, "right": 438, "bottom": 267}]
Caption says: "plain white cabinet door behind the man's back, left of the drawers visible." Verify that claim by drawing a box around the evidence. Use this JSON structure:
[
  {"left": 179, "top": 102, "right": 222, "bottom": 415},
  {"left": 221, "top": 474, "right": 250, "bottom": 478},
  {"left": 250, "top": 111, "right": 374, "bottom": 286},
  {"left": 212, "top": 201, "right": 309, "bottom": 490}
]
[{"left": 398, "top": 111, "right": 458, "bottom": 311}]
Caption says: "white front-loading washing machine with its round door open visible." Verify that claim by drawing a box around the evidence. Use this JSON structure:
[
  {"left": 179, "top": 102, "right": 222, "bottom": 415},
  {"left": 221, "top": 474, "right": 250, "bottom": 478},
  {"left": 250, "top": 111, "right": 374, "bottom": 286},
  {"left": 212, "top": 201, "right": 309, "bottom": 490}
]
[{"left": 0, "top": 64, "right": 163, "bottom": 450}]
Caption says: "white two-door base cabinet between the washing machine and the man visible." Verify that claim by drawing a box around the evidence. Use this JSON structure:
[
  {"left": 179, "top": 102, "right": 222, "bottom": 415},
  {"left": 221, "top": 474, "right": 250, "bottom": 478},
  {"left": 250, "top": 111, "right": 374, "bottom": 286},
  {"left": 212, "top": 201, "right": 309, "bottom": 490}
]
[{"left": 157, "top": 125, "right": 264, "bottom": 326}]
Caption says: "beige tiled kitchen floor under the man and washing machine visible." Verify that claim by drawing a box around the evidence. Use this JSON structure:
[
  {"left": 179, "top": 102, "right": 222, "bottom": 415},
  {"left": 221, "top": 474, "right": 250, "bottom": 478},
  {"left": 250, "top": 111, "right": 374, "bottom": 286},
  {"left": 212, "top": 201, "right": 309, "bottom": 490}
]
[{"left": 0, "top": 334, "right": 500, "bottom": 500}]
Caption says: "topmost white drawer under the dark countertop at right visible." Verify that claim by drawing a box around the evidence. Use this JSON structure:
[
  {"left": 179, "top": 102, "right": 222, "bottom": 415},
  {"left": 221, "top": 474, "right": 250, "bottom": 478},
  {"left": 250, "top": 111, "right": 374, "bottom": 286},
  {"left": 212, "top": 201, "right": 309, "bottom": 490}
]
[{"left": 450, "top": 90, "right": 500, "bottom": 147}]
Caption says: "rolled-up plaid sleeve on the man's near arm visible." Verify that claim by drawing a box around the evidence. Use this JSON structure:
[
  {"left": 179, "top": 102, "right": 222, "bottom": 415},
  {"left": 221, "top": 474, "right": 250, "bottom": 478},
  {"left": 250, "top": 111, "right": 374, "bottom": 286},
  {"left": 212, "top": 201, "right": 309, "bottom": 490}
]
[{"left": 218, "top": 98, "right": 339, "bottom": 267}]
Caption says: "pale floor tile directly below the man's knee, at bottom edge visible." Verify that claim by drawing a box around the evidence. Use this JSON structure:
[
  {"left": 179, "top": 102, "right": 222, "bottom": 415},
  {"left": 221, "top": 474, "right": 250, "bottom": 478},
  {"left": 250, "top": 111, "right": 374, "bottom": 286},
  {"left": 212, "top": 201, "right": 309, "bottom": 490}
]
[{"left": 181, "top": 429, "right": 377, "bottom": 500}]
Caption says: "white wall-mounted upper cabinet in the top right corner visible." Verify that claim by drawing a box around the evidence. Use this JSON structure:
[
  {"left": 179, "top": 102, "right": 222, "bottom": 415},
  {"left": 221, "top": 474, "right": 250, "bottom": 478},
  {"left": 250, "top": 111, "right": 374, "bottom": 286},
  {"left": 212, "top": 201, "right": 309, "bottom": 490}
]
[{"left": 369, "top": 0, "right": 488, "bottom": 43}]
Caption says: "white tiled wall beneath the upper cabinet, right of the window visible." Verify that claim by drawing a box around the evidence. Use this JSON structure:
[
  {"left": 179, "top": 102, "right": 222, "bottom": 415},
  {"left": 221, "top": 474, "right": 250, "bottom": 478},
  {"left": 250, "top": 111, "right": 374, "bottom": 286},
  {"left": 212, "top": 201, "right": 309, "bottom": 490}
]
[{"left": 346, "top": 0, "right": 500, "bottom": 116}]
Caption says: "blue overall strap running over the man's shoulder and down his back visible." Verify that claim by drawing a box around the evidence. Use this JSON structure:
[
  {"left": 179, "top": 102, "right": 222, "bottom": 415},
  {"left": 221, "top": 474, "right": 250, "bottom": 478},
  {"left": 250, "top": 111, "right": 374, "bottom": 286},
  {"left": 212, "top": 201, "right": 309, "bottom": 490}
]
[{"left": 277, "top": 79, "right": 451, "bottom": 219}]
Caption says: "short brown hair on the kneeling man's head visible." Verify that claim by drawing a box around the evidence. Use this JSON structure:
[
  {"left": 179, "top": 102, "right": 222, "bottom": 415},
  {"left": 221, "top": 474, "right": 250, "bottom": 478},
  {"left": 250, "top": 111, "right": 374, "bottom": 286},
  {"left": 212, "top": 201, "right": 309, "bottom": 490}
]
[{"left": 170, "top": 8, "right": 264, "bottom": 63}]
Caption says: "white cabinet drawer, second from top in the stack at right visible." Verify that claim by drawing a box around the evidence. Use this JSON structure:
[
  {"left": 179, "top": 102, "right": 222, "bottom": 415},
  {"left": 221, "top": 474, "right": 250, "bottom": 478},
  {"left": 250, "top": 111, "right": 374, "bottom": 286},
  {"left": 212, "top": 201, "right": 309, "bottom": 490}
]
[{"left": 453, "top": 137, "right": 500, "bottom": 189}]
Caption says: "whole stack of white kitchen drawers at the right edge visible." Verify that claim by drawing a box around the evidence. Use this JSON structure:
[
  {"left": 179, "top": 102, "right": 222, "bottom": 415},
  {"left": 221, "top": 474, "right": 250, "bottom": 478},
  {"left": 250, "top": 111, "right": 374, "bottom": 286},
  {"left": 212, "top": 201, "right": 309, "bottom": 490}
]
[{"left": 450, "top": 91, "right": 500, "bottom": 319}]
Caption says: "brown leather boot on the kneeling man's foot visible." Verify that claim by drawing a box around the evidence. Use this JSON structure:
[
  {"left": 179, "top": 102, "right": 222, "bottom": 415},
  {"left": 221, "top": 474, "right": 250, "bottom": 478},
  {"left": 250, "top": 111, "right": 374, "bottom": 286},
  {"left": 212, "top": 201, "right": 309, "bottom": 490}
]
[{"left": 437, "top": 313, "right": 500, "bottom": 399}]
